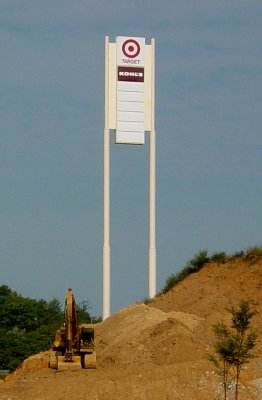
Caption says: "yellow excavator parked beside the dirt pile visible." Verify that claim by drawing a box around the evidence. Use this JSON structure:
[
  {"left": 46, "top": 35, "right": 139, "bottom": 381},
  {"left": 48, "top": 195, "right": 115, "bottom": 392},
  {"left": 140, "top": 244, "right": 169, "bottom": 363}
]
[{"left": 49, "top": 289, "right": 96, "bottom": 371}]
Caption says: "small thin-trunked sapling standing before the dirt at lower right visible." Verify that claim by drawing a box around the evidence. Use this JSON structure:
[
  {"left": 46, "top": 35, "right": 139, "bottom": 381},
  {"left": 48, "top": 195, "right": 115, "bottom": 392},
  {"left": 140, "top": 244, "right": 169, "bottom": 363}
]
[{"left": 210, "top": 300, "right": 257, "bottom": 400}]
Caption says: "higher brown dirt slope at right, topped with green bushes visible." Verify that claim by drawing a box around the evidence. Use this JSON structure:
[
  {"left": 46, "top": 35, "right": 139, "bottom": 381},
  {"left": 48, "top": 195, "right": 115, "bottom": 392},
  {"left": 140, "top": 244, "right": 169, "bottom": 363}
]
[{"left": 150, "top": 258, "right": 262, "bottom": 353}]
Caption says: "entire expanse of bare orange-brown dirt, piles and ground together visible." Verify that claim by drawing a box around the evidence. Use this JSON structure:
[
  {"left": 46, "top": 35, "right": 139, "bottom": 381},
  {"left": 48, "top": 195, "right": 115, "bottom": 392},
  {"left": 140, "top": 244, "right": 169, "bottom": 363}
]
[{"left": 0, "top": 260, "right": 262, "bottom": 400}]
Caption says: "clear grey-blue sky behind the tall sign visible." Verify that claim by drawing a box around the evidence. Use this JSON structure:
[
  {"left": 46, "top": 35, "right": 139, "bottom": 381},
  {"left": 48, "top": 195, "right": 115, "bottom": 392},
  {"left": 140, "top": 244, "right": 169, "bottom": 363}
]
[{"left": 0, "top": 0, "right": 262, "bottom": 316}]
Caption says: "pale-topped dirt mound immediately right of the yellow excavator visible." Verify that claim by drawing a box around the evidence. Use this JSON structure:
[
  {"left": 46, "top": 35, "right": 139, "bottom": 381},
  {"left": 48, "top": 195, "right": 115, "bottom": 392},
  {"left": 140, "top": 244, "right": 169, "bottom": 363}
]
[{"left": 97, "top": 304, "right": 204, "bottom": 367}]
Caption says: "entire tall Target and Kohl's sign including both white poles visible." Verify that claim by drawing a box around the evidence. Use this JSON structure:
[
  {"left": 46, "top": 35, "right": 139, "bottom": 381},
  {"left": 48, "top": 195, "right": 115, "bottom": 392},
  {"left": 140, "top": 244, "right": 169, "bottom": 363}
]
[{"left": 103, "top": 36, "right": 156, "bottom": 319}]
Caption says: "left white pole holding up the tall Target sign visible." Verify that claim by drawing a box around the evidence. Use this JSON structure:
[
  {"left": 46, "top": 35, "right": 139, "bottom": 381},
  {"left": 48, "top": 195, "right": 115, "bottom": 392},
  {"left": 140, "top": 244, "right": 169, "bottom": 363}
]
[{"left": 103, "top": 36, "right": 110, "bottom": 320}]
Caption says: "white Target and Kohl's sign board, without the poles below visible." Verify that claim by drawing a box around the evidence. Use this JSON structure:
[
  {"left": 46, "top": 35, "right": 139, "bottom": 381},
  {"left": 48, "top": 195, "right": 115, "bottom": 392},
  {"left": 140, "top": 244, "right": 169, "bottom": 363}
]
[{"left": 105, "top": 36, "right": 154, "bottom": 144}]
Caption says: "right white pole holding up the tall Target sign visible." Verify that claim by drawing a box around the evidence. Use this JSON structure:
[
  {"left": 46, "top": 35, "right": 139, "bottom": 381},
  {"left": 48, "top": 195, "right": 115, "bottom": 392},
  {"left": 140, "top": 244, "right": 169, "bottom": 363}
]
[{"left": 148, "top": 39, "right": 156, "bottom": 298}]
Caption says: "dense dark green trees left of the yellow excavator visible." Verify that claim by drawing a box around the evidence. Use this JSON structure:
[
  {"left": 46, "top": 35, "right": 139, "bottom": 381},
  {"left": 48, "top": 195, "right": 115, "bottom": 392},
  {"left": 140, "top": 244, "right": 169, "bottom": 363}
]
[{"left": 0, "top": 285, "right": 63, "bottom": 370}]
